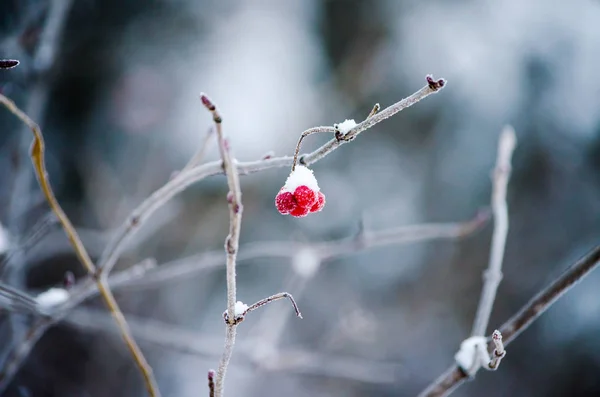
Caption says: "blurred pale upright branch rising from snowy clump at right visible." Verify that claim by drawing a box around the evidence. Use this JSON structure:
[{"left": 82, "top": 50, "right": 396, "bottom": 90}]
[{"left": 471, "top": 126, "right": 516, "bottom": 336}]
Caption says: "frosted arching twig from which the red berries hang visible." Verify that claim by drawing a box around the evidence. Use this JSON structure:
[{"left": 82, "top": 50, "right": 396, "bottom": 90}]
[{"left": 98, "top": 76, "right": 445, "bottom": 273}]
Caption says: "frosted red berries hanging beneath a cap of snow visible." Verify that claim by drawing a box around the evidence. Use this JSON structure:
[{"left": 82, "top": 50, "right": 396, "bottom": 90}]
[{"left": 275, "top": 185, "right": 325, "bottom": 218}]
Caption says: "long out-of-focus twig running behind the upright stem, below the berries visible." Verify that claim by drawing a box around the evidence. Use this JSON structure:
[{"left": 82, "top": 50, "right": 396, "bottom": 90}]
[{"left": 0, "top": 211, "right": 482, "bottom": 390}]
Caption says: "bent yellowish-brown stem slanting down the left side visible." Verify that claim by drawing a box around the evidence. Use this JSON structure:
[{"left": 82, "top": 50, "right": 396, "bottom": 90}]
[{"left": 0, "top": 94, "right": 160, "bottom": 397}]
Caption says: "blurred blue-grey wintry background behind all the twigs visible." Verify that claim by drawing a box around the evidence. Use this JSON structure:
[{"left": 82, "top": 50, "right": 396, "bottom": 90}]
[{"left": 0, "top": 0, "right": 600, "bottom": 397}]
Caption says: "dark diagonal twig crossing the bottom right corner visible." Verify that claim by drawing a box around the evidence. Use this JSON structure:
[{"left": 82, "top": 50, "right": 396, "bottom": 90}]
[{"left": 419, "top": 245, "right": 600, "bottom": 397}]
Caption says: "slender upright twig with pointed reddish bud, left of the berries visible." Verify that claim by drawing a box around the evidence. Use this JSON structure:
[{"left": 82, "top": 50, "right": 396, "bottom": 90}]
[{"left": 200, "top": 94, "right": 242, "bottom": 397}]
